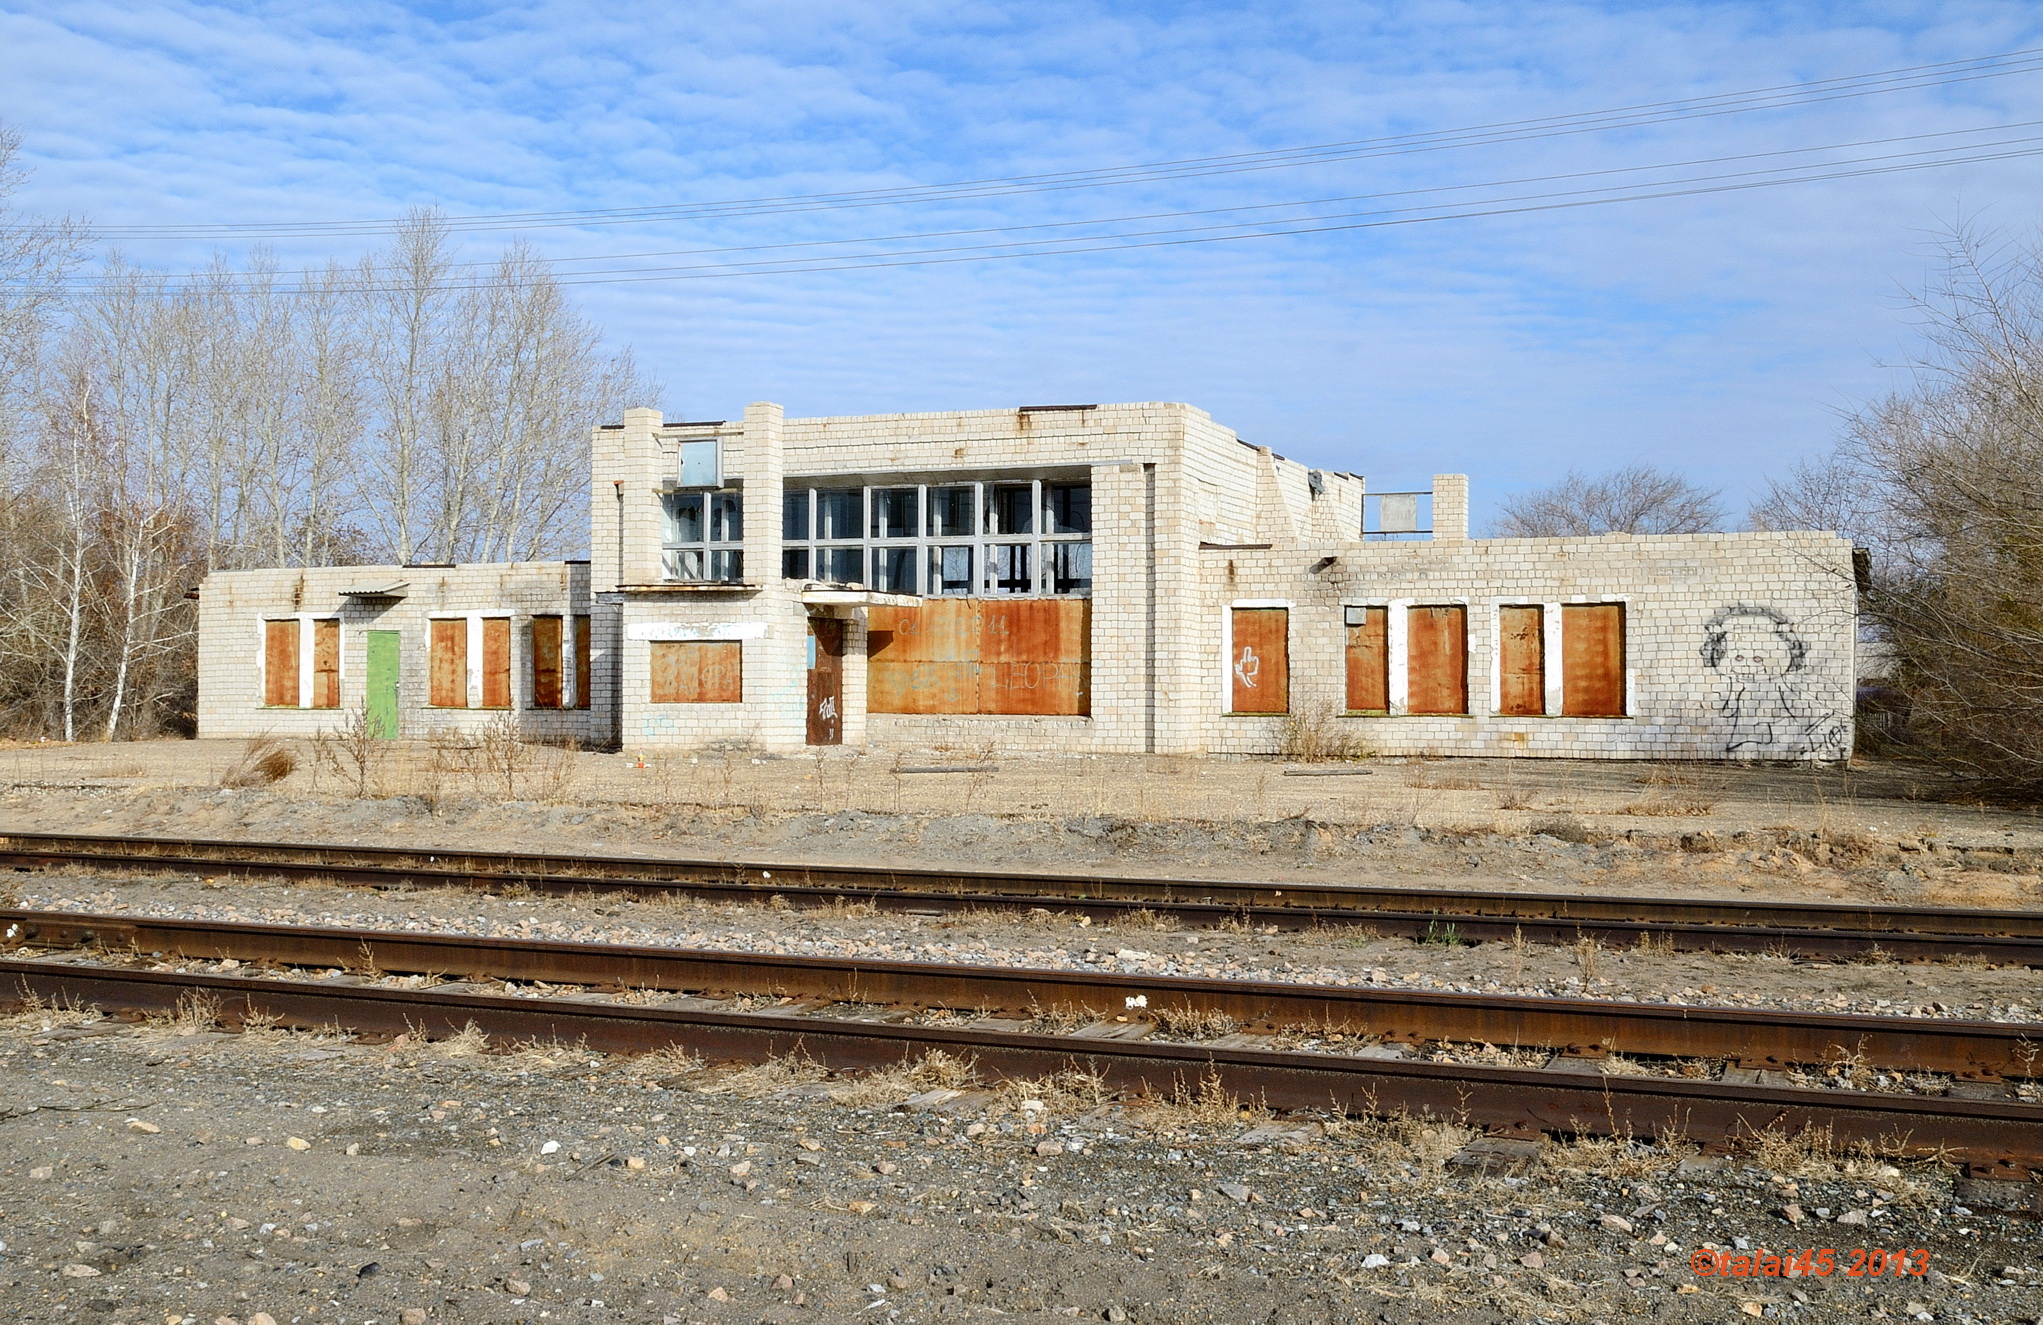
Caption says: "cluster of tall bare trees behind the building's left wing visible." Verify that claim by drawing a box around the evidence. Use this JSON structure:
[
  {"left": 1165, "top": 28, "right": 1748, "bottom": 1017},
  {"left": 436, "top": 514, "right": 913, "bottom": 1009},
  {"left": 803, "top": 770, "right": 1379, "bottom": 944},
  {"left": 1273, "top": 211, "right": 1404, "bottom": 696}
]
[{"left": 0, "top": 131, "right": 656, "bottom": 739}]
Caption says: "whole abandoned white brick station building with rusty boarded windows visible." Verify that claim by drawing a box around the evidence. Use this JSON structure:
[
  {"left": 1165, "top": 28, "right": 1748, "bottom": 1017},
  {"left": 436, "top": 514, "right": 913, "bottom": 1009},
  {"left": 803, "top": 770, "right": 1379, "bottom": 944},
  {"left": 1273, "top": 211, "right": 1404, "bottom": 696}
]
[{"left": 198, "top": 404, "right": 1857, "bottom": 759}]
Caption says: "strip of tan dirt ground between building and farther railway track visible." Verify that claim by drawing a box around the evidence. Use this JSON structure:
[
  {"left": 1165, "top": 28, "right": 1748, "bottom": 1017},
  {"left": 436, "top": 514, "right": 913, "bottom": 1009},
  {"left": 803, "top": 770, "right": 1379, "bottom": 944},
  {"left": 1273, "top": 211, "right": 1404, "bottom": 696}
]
[{"left": 0, "top": 741, "right": 2043, "bottom": 906}]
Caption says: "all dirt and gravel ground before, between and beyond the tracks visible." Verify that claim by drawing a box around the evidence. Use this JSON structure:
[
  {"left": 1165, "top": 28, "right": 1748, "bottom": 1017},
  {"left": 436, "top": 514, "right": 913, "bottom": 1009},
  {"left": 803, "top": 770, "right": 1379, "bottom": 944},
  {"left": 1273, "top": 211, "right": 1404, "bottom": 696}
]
[{"left": 0, "top": 741, "right": 2043, "bottom": 1325}]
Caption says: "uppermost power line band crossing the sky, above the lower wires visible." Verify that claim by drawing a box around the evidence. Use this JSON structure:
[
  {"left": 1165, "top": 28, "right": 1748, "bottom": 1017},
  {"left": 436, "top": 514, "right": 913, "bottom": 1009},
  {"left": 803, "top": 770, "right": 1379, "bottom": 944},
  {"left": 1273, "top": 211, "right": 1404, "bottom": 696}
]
[{"left": 83, "top": 47, "right": 2043, "bottom": 239}]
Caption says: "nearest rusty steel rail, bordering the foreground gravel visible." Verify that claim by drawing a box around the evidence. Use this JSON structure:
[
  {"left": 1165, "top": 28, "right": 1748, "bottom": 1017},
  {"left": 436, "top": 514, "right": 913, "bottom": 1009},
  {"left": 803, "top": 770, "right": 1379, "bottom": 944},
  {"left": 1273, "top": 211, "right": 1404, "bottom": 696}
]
[{"left": 0, "top": 960, "right": 2043, "bottom": 1176}]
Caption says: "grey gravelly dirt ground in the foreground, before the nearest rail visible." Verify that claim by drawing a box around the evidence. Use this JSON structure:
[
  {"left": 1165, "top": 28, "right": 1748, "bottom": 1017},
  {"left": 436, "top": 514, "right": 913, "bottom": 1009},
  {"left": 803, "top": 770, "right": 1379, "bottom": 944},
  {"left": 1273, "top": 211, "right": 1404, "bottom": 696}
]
[{"left": 0, "top": 1013, "right": 2043, "bottom": 1325}]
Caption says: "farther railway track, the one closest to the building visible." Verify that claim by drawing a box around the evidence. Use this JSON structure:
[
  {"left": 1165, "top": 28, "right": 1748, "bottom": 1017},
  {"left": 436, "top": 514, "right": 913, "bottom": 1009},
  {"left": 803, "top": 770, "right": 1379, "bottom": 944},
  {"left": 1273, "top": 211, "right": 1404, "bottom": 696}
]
[{"left": 0, "top": 833, "right": 2043, "bottom": 966}]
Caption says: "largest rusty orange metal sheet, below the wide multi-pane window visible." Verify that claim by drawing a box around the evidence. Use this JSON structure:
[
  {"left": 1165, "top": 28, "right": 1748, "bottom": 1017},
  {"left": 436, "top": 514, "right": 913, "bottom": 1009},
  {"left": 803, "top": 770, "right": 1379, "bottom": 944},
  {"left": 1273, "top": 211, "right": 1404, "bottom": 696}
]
[{"left": 866, "top": 598, "right": 1093, "bottom": 717}]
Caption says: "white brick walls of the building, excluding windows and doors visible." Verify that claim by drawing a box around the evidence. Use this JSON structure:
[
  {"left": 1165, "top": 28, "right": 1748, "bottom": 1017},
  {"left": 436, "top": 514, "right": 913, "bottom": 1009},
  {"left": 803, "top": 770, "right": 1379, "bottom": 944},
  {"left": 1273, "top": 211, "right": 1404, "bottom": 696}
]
[{"left": 200, "top": 402, "right": 1855, "bottom": 757}]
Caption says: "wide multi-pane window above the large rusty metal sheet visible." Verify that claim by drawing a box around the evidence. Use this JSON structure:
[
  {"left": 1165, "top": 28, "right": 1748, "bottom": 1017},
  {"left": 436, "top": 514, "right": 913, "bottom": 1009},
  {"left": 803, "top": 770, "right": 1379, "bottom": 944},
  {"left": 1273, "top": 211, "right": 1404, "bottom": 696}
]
[{"left": 780, "top": 478, "right": 1093, "bottom": 598}]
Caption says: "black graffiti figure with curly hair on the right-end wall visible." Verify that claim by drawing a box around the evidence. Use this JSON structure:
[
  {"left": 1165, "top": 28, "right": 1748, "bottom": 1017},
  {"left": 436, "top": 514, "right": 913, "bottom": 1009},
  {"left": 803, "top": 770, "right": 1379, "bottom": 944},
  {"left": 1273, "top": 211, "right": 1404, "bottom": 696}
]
[{"left": 1702, "top": 602, "right": 1849, "bottom": 759}]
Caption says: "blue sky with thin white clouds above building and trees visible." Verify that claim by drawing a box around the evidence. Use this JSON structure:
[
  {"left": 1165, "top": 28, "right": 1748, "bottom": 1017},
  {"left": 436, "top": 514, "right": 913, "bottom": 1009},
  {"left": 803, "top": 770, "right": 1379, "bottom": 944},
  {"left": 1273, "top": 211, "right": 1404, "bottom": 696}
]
[{"left": 0, "top": 0, "right": 2043, "bottom": 512}]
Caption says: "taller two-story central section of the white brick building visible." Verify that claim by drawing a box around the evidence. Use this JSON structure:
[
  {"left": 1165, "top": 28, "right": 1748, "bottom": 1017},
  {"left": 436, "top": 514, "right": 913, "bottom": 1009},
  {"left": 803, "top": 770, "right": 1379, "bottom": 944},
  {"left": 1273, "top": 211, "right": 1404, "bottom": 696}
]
[{"left": 590, "top": 404, "right": 1361, "bottom": 751}]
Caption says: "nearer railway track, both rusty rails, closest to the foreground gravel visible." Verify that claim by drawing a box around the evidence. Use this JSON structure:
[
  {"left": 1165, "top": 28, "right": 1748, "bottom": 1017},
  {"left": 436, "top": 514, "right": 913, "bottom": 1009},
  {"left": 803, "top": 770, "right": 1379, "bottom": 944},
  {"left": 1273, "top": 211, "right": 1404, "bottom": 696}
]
[{"left": 0, "top": 911, "right": 2043, "bottom": 1178}]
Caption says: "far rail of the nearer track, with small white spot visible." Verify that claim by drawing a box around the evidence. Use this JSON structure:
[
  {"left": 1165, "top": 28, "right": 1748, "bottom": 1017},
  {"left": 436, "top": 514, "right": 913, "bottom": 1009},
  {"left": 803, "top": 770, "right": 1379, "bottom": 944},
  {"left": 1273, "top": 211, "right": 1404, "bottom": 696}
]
[{"left": 0, "top": 911, "right": 2043, "bottom": 1082}]
